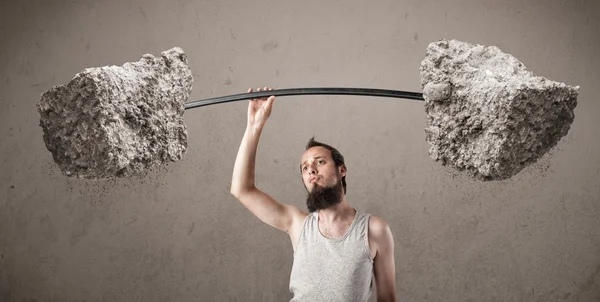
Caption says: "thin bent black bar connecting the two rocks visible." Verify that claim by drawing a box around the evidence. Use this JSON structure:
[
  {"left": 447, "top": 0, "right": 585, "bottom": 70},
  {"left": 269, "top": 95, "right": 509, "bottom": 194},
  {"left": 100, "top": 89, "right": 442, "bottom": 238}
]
[{"left": 185, "top": 87, "right": 424, "bottom": 109}]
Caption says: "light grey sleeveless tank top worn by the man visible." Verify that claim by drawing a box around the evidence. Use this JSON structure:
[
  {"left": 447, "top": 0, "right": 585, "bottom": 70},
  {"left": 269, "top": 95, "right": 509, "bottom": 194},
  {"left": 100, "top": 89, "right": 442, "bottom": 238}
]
[{"left": 290, "top": 211, "right": 373, "bottom": 302}]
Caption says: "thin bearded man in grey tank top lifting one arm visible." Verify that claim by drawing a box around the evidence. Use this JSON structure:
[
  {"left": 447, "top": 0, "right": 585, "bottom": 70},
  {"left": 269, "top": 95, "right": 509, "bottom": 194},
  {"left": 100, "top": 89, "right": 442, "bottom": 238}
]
[{"left": 231, "top": 87, "right": 396, "bottom": 302}]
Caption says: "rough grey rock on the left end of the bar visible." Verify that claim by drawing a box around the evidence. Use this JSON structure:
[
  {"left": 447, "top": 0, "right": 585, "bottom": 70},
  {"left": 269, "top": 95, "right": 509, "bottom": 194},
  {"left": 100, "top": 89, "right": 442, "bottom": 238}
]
[{"left": 37, "top": 47, "right": 193, "bottom": 179}]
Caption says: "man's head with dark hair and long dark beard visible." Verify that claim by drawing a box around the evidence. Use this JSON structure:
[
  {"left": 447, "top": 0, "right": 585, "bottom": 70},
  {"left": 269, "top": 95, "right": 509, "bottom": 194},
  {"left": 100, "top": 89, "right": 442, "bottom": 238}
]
[{"left": 300, "top": 137, "right": 346, "bottom": 212}]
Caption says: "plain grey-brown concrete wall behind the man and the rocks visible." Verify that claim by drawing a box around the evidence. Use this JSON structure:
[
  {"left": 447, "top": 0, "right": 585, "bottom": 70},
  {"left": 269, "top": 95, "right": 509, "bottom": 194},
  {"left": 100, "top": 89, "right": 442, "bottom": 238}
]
[{"left": 0, "top": 0, "right": 600, "bottom": 301}]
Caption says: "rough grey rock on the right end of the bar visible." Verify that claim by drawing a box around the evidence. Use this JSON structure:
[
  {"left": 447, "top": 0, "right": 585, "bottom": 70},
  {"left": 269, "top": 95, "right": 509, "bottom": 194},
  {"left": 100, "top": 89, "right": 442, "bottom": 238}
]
[{"left": 420, "top": 40, "right": 579, "bottom": 180}]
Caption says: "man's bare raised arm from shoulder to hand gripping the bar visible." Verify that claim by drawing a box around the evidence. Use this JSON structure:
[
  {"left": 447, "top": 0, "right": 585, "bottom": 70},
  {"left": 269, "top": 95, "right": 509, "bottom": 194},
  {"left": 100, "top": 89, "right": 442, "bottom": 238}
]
[{"left": 231, "top": 87, "right": 302, "bottom": 234}]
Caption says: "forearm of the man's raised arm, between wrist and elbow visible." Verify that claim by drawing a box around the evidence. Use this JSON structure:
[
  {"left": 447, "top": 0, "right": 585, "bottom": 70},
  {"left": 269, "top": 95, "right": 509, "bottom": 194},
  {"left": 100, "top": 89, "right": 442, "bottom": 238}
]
[{"left": 231, "top": 124, "right": 262, "bottom": 195}]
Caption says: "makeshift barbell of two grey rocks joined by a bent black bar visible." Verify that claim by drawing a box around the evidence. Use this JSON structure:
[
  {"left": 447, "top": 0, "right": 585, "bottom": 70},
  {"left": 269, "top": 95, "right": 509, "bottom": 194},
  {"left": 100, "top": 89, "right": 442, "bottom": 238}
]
[{"left": 37, "top": 39, "right": 579, "bottom": 181}]
